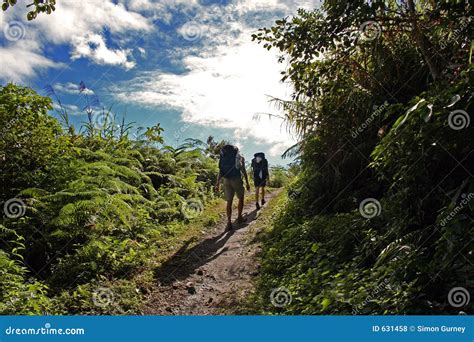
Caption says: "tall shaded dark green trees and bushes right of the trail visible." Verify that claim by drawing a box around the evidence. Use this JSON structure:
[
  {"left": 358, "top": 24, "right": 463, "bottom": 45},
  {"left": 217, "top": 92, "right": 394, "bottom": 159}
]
[{"left": 252, "top": 1, "right": 474, "bottom": 314}]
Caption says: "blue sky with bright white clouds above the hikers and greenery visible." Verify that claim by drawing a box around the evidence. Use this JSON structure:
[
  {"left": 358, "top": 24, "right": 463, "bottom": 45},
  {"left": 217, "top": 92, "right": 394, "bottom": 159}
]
[{"left": 0, "top": 0, "right": 320, "bottom": 165}]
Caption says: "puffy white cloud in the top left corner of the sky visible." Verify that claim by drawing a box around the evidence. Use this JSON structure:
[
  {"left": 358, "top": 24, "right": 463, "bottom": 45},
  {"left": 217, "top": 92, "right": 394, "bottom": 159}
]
[{"left": 0, "top": 0, "right": 153, "bottom": 82}]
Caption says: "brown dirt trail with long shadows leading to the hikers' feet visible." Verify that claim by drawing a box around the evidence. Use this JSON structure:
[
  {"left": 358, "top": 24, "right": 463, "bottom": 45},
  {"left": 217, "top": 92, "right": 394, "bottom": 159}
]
[{"left": 144, "top": 191, "right": 278, "bottom": 315}]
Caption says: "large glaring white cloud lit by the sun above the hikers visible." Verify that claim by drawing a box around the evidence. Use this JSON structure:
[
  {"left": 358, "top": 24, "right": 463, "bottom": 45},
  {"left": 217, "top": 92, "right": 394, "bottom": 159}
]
[{"left": 114, "top": 32, "right": 294, "bottom": 155}]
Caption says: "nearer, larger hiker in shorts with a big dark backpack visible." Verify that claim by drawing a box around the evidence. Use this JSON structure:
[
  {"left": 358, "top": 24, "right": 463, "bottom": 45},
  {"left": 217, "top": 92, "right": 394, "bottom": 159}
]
[{"left": 216, "top": 145, "right": 250, "bottom": 230}]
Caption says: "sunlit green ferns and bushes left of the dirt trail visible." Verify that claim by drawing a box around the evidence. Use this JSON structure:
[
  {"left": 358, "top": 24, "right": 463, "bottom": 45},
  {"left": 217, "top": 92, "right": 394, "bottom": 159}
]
[{"left": 0, "top": 84, "right": 219, "bottom": 314}]
